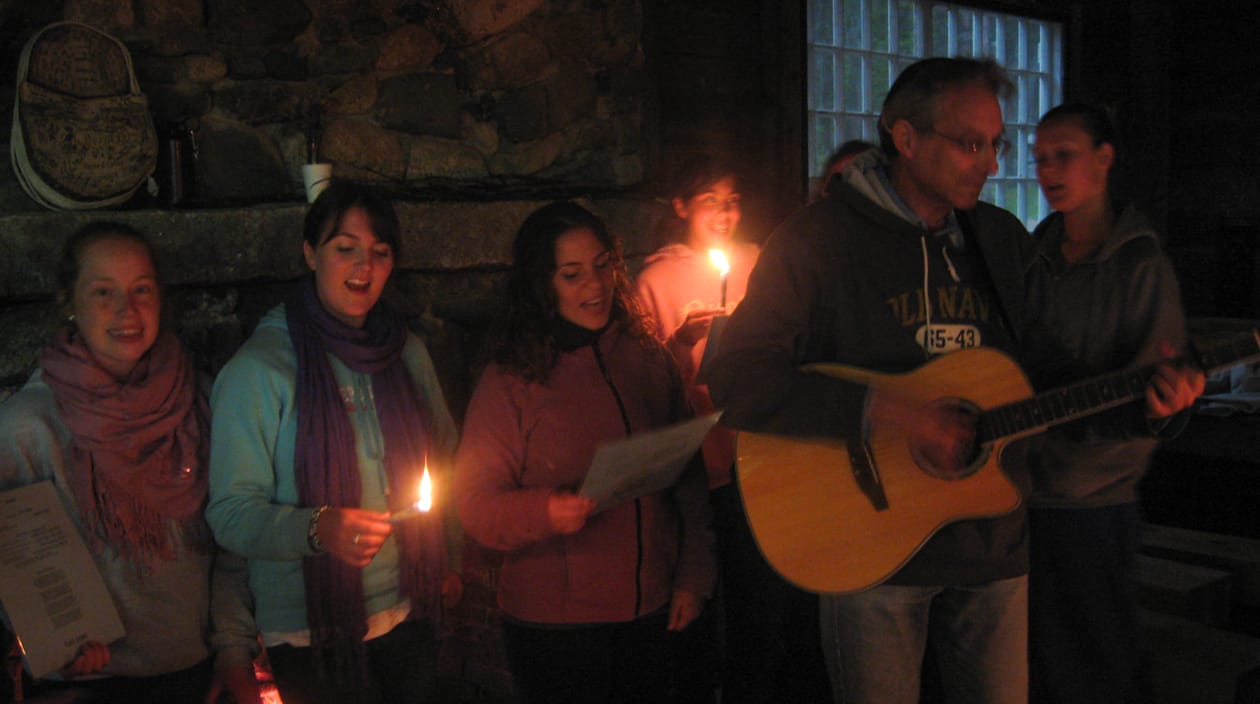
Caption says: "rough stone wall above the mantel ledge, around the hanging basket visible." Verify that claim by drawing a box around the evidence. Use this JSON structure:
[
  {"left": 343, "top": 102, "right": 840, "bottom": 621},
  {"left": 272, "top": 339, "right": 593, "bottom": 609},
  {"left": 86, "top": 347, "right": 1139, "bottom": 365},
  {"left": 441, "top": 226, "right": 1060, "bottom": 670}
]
[{"left": 0, "top": 0, "right": 644, "bottom": 210}]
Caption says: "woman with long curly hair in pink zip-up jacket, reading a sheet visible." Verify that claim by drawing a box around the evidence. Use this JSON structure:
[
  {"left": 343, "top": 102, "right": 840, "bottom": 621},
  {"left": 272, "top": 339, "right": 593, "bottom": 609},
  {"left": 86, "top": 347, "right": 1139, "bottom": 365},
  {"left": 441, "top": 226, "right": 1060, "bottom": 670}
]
[{"left": 455, "top": 203, "right": 717, "bottom": 704}]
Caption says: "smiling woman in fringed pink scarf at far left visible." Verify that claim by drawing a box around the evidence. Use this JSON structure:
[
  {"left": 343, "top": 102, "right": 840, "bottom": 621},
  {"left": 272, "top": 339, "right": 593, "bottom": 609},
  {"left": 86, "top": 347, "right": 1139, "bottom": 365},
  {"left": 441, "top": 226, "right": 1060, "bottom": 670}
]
[{"left": 0, "top": 223, "right": 258, "bottom": 704}]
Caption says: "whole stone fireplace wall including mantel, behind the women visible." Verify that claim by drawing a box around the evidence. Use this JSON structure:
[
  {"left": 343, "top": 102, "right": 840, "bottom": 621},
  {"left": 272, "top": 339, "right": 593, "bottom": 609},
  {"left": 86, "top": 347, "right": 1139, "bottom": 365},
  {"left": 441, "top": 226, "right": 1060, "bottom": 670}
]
[{"left": 0, "top": 0, "right": 664, "bottom": 701}]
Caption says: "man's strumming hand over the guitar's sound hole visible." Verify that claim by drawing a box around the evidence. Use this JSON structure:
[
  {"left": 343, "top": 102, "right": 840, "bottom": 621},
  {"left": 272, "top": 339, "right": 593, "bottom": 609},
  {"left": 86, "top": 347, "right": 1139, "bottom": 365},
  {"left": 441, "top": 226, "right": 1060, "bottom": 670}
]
[{"left": 867, "top": 388, "right": 977, "bottom": 479}]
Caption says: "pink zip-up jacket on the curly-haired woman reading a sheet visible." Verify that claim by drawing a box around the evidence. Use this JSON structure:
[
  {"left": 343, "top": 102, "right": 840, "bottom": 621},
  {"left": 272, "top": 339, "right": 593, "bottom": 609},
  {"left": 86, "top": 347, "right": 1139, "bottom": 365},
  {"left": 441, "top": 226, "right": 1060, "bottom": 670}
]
[{"left": 455, "top": 325, "right": 714, "bottom": 625}]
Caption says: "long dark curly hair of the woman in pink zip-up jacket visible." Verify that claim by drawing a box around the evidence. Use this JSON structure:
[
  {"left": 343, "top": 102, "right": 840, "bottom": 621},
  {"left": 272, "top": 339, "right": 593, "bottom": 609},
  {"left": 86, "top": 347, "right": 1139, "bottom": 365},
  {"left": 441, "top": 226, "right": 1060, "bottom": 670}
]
[{"left": 490, "top": 202, "right": 654, "bottom": 382}]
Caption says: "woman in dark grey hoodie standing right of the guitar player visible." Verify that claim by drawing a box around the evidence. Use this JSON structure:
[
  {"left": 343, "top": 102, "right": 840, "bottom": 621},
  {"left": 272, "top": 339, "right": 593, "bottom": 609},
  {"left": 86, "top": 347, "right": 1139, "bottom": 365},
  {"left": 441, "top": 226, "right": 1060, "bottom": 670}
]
[{"left": 1023, "top": 105, "right": 1203, "bottom": 704}]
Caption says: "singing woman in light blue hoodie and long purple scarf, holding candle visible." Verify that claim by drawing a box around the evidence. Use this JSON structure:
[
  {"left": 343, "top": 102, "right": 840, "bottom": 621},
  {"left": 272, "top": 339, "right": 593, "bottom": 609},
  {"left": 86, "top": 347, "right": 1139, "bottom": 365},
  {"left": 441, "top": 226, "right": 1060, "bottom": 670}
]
[{"left": 207, "top": 184, "right": 462, "bottom": 704}]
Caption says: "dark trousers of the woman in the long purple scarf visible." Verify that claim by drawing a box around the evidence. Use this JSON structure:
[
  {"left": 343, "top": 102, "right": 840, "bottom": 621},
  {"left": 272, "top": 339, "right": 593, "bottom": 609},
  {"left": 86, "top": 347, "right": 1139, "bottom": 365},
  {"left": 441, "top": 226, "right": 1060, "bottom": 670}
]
[{"left": 267, "top": 621, "right": 438, "bottom": 704}]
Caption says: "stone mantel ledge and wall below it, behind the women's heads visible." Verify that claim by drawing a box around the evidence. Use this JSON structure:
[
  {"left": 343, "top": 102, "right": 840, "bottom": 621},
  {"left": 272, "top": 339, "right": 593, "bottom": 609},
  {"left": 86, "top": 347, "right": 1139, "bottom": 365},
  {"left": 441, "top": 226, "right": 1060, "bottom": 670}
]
[{"left": 0, "top": 198, "right": 665, "bottom": 400}]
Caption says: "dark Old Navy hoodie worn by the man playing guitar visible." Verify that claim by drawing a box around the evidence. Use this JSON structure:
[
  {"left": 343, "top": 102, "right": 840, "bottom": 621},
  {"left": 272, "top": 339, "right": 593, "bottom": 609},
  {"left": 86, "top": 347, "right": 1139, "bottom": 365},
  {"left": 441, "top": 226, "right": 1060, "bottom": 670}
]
[{"left": 709, "top": 155, "right": 1032, "bottom": 584}]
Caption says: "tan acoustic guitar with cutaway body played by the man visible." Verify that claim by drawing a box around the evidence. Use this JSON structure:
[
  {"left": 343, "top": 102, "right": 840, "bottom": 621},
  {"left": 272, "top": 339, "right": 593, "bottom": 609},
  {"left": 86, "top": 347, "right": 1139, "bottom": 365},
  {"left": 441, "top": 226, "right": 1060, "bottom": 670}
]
[{"left": 736, "top": 330, "right": 1260, "bottom": 593}]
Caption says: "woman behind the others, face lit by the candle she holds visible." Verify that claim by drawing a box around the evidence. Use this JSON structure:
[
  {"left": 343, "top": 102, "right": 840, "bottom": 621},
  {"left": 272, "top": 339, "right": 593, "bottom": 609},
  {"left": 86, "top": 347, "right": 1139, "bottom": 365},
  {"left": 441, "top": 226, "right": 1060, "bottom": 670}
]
[{"left": 638, "top": 155, "right": 830, "bottom": 703}]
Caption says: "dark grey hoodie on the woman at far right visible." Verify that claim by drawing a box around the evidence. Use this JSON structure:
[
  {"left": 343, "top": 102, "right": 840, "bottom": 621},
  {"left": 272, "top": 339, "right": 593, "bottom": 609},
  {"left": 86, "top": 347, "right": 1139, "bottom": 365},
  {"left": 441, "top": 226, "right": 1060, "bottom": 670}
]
[{"left": 1022, "top": 208, "right": 1186, "bottom": 508}]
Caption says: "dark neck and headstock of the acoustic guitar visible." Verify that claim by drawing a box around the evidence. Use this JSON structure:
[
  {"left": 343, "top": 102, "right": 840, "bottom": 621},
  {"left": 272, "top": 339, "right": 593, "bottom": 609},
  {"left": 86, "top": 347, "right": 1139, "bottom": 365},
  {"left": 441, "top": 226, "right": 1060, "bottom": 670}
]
[{"left": 977, "top": 330, "right": 1260, "bottom": 443}]
